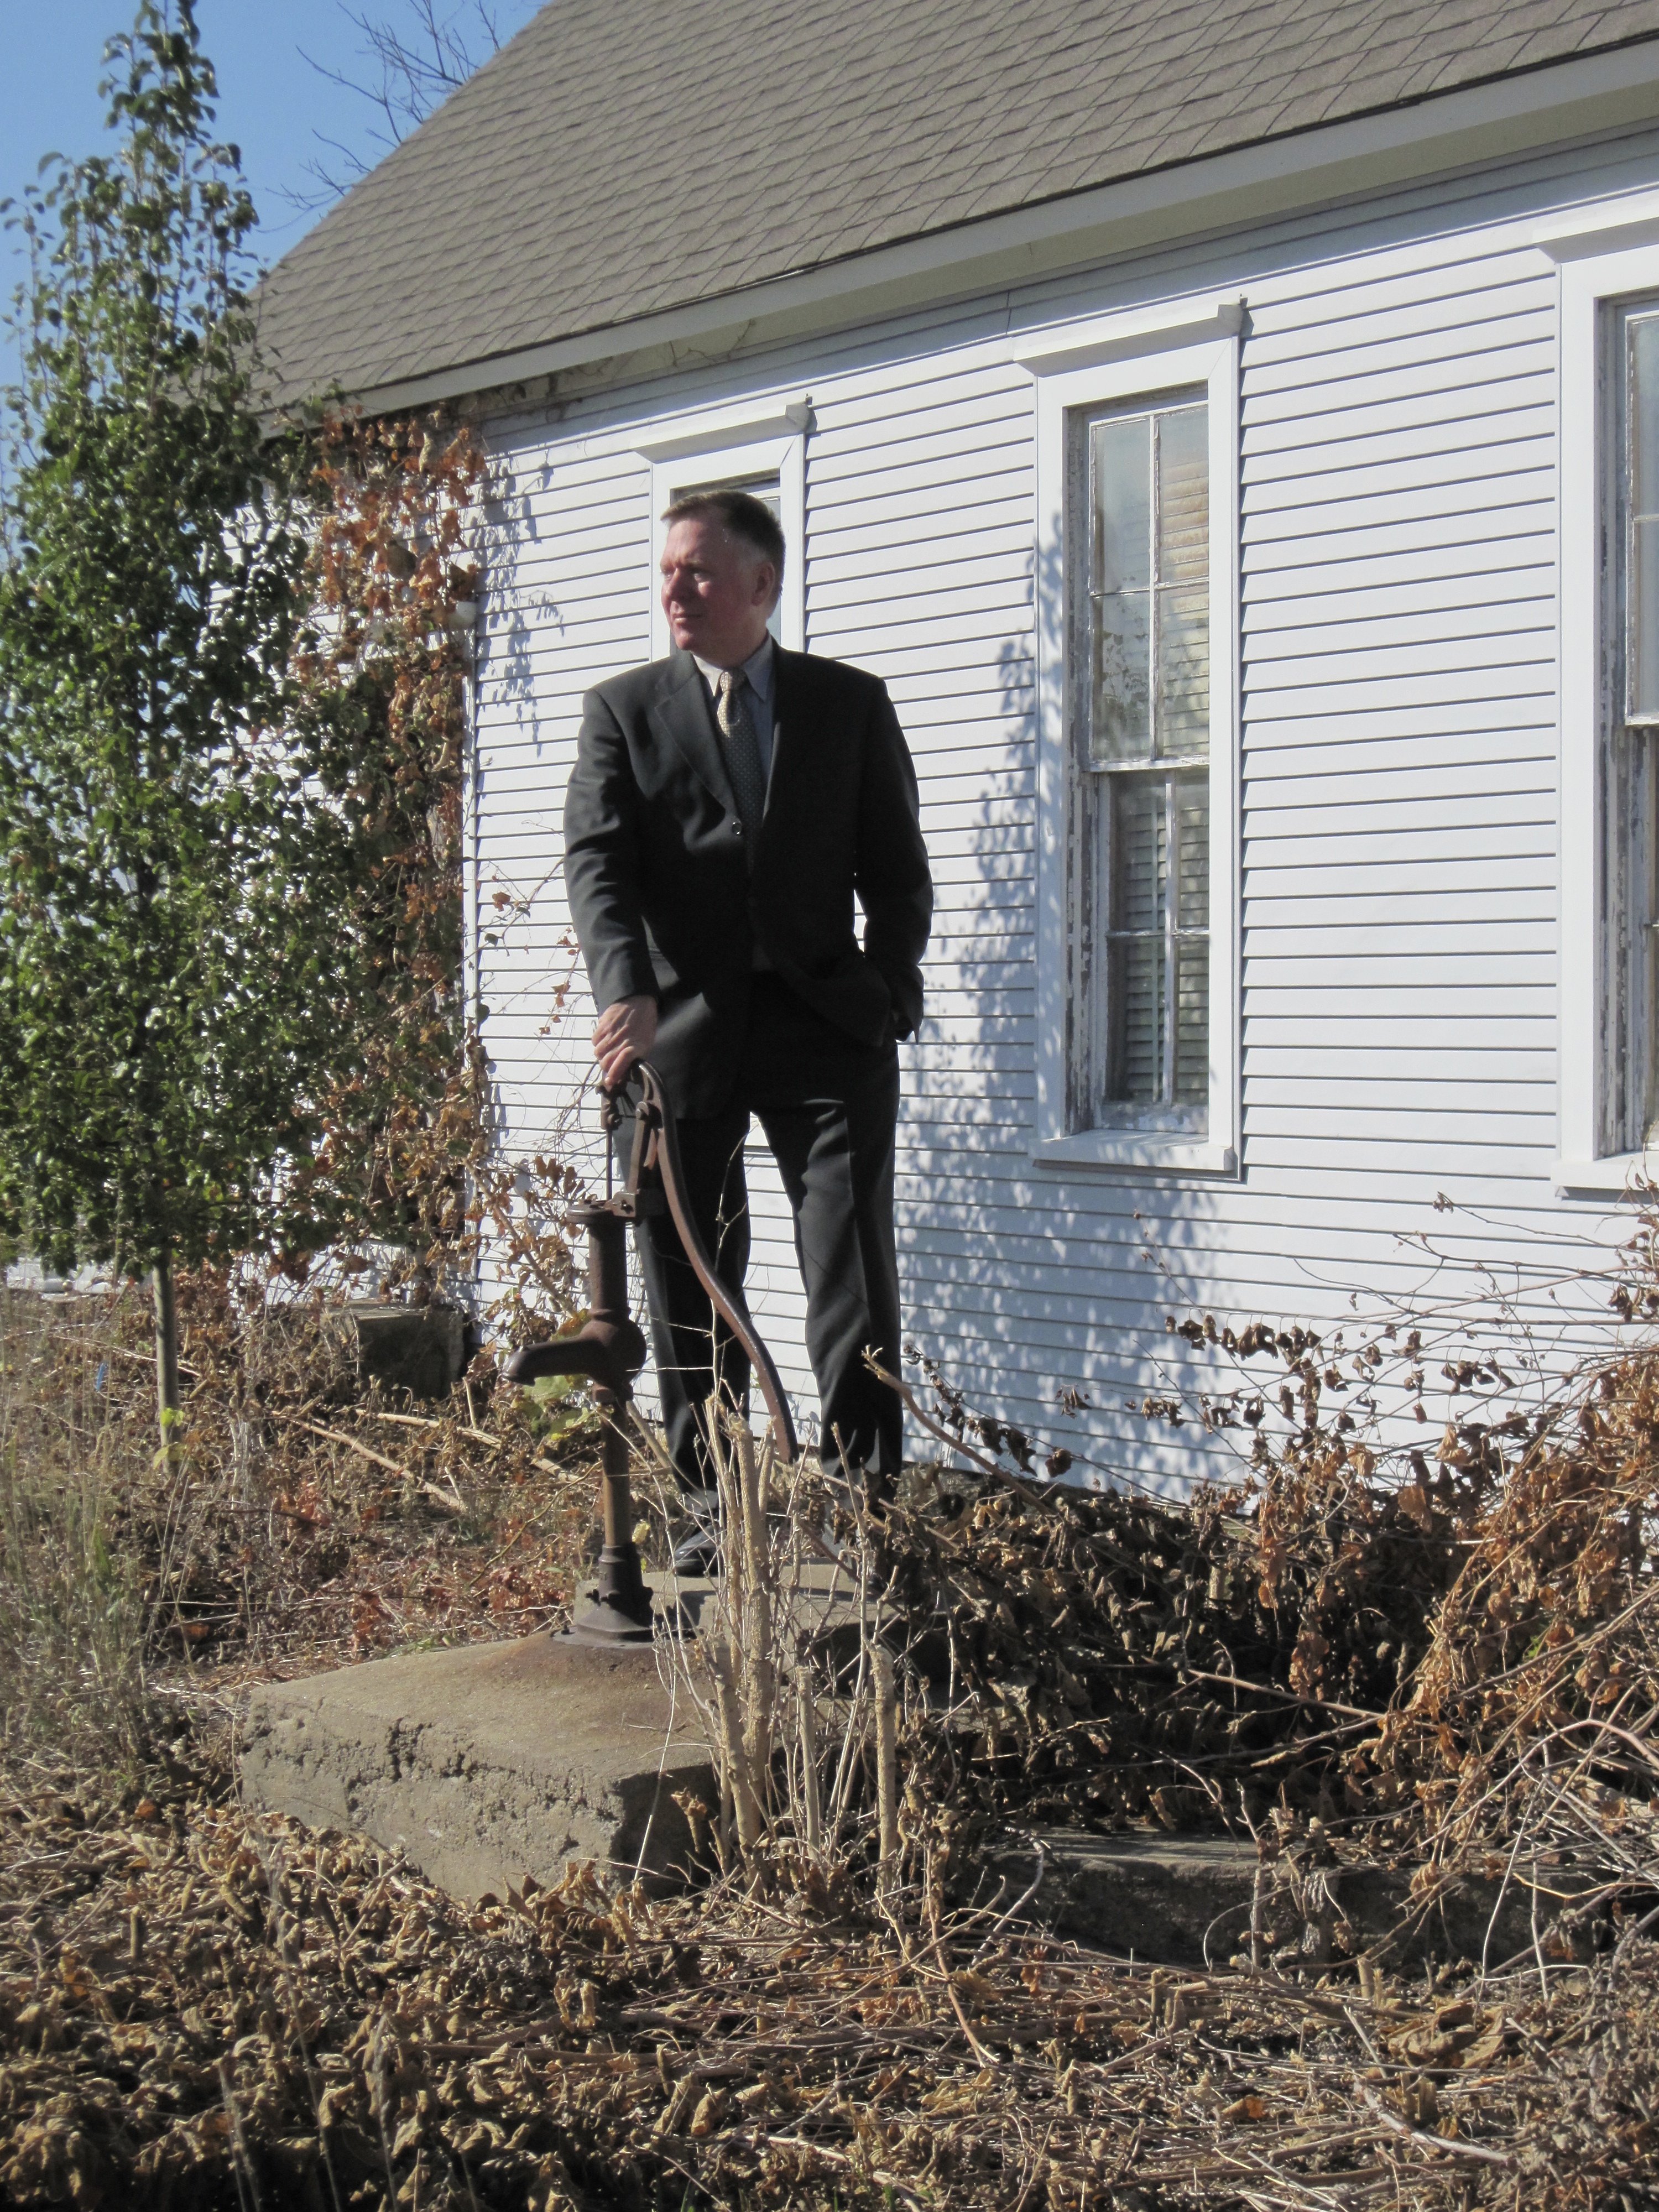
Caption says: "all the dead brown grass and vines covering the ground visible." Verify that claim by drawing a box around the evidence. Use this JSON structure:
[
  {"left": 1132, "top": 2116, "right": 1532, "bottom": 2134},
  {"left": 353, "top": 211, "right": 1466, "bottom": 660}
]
[{"left": 0, "top": 1285, "right": 1659, "bottom": 2212}]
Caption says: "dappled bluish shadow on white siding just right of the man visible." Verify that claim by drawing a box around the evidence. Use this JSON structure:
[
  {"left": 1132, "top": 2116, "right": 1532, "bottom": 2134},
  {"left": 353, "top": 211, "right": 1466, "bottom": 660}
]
[{"left": 898, "top": 469, "right": 1232, "bottom": 1493}]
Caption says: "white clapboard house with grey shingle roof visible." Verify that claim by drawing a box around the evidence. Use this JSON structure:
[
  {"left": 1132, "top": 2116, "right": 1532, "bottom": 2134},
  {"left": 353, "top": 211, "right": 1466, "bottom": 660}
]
[{"left": 265, "top": 0, "right": 1659, "bottom": 1480}]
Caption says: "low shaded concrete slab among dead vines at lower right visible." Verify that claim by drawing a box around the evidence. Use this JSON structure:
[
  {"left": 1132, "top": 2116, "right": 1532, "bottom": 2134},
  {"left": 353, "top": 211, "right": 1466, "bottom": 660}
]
[{"left": 1026, "top": 1829, "right": 1533, "bottom": 1966}]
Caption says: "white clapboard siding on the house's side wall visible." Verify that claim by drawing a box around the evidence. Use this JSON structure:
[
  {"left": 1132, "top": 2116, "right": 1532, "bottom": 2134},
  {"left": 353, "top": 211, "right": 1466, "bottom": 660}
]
[{"left": 462, "top": 150, "right": 1659, "bottom": 1489}]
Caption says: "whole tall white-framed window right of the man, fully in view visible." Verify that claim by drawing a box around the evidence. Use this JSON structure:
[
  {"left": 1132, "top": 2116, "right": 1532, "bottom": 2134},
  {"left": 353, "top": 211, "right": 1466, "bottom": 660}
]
[{"left": 1018, "top": 301, "right": 1241, "bottom": 1172}]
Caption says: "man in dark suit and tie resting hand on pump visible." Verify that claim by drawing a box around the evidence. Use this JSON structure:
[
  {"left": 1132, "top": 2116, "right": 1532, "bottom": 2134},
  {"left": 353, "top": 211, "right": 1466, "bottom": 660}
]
[{"left": 564, "top": 491, "right": 933, "bottom": 1522}]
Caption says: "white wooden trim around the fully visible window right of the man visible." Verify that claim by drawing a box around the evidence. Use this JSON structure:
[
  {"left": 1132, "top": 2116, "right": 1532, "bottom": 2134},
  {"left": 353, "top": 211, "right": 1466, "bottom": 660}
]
[{"left": 1015, "top": 323, "right": 1243, "bottom": 1175}]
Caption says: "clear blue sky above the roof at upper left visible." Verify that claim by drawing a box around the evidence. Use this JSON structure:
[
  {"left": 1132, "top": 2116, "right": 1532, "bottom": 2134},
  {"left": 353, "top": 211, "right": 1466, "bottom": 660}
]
[{"left": 0, "top": 0, "right": 538, "bottom": 305}]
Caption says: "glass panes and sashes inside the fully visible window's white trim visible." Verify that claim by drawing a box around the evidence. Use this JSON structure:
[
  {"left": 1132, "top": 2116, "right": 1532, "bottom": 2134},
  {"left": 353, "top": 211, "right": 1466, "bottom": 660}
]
[{"left": 1068, "top": 389, "right": 1210, "bottom": 1133}]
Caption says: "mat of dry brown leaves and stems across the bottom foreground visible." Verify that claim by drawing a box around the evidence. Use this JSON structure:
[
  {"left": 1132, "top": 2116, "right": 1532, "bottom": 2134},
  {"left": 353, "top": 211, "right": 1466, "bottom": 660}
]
[{"left": 0, "top": 1756, "right": 1659, "bottom": 2212}]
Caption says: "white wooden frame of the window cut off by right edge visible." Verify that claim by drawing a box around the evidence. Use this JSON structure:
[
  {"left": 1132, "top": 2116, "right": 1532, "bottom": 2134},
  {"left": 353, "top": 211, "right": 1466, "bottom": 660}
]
[{"left": 1540, "top": 233, "right": 1659, "bottom": 1192}]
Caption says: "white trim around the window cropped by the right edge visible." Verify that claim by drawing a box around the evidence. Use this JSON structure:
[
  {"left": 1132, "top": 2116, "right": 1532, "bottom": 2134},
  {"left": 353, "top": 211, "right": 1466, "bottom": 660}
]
[{"left": 1540, "top": 242, "right": 1659, "bottom": 1190}]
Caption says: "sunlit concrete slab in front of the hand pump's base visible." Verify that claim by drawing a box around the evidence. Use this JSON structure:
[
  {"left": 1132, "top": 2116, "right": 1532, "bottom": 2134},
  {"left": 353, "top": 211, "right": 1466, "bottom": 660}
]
[{"left": 239, "top": 1635, "right": 719, "bottom": 1898}]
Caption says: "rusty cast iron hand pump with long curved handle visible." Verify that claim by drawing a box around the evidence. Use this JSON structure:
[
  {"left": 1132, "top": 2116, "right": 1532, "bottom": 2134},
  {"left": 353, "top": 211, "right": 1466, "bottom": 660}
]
[{"left": 502, "top": 1060, "right": 796, "bottom": 1644}]
